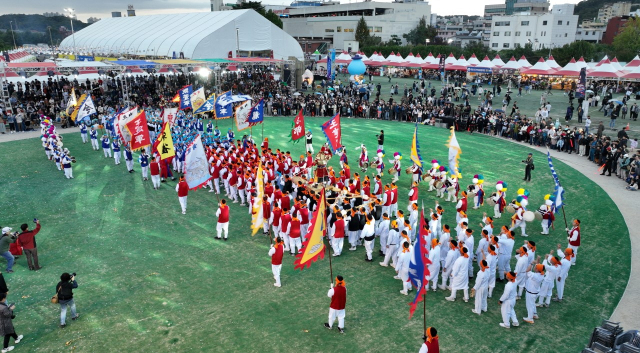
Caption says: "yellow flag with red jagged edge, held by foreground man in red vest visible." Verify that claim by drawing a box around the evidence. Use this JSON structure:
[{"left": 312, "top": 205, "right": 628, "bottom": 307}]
[{"left": 293, "top": 188, "right": 327, "bottom": 271}]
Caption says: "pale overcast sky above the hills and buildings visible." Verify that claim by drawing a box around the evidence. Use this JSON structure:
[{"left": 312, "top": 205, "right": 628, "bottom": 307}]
[{"left": 0, "top": 0, "right": 579, "bottom": 21}]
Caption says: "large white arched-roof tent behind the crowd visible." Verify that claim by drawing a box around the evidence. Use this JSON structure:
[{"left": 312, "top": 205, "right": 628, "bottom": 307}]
[{"left": 60, "top": 10, "right": 304, "bottom": 59}]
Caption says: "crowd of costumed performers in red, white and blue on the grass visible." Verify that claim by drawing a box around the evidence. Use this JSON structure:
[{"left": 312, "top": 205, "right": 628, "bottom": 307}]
[{"left": 42, "top": 116, "right": 580, "bottom": 352}]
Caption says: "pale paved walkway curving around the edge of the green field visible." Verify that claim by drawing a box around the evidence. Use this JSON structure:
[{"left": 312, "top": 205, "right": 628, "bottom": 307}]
[{"left": 5, "top": 127, "right": 640, "bottom": 330}]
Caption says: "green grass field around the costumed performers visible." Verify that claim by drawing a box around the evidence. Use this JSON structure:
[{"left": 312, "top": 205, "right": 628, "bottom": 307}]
[{"left": 0, "top": 118, "right": 631, "bottom": 352}]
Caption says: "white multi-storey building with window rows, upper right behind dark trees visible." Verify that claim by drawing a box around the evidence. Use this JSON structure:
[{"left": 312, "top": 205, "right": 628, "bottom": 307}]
[{"left": 489, "top": 4, "right": 578, "bottom": 50}]
